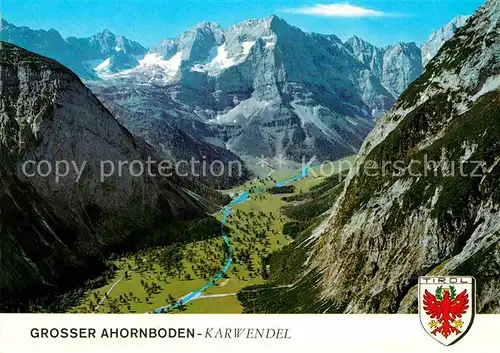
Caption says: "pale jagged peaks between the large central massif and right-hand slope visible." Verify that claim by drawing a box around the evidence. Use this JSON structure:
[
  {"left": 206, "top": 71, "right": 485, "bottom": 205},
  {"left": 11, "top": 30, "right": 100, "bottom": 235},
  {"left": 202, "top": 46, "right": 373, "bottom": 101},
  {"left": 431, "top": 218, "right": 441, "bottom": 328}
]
[{"left": 345, "top": 36, "right": 422, "bottom": 97}]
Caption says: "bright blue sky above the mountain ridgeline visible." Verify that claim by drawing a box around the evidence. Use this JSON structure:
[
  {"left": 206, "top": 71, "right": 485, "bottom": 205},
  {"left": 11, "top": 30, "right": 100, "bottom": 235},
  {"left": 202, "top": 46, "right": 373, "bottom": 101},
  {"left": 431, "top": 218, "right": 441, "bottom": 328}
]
[{"left": 2, "top": 0, "right": 484, "bottom": 46}]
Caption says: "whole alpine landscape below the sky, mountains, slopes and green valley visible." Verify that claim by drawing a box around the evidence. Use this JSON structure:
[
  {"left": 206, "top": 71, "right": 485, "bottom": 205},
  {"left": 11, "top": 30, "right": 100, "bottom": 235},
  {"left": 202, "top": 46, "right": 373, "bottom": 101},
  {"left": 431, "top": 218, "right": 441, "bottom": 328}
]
[{"left": 0, "top": 0, "right": 500, "bottom": 313}]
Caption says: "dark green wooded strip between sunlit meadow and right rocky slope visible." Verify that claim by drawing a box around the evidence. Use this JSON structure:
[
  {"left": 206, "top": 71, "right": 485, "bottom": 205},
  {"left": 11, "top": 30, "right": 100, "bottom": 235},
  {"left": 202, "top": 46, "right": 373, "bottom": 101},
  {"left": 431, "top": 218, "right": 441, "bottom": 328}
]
[{"left": 237, "top": 171, "right": 347, "bottom": 313}]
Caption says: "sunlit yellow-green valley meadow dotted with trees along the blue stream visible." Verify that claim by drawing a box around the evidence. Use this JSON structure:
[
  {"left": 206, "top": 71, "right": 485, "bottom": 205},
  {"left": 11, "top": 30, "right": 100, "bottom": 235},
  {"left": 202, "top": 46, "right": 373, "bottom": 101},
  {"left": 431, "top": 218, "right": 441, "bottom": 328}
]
[{"left": 71, "top": 161, "right": 332, "bottom": 313}]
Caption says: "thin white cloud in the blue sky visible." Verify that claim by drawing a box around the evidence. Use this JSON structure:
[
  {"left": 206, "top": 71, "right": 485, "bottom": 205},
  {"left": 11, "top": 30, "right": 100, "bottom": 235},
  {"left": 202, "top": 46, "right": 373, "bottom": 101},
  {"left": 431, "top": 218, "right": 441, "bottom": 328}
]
[{"left": 287, "top": 3, "right": 388, "bottom": 17}]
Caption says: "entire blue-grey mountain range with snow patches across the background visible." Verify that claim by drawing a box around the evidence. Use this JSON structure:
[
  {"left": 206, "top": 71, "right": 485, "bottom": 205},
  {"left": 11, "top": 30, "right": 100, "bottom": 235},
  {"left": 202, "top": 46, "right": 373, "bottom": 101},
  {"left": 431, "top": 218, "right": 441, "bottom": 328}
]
[{"left": 2, "top": 16, "right": 446, "bottom": 170}]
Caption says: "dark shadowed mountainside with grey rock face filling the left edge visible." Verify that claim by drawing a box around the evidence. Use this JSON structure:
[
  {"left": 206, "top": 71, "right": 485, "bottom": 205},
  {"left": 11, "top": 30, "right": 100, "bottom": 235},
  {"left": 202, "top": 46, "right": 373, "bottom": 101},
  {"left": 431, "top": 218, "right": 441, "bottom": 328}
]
[{"left": 0, "top": 42, "right": 202, "bottom": 306}]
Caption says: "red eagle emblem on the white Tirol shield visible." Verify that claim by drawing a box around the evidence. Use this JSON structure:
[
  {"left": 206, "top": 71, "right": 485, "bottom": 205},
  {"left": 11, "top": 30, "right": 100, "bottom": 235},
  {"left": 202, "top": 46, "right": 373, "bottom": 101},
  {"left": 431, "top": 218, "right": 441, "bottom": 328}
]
[{"left": 423, "top": 286, "right": 469, "bottom": 338}]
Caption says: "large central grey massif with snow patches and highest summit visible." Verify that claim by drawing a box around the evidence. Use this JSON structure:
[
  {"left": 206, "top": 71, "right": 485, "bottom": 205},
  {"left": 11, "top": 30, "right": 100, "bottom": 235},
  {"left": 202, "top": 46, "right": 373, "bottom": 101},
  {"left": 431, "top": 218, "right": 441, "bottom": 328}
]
[{"left": 89, "top": 16, "right": 394, "bottom": 168}]
